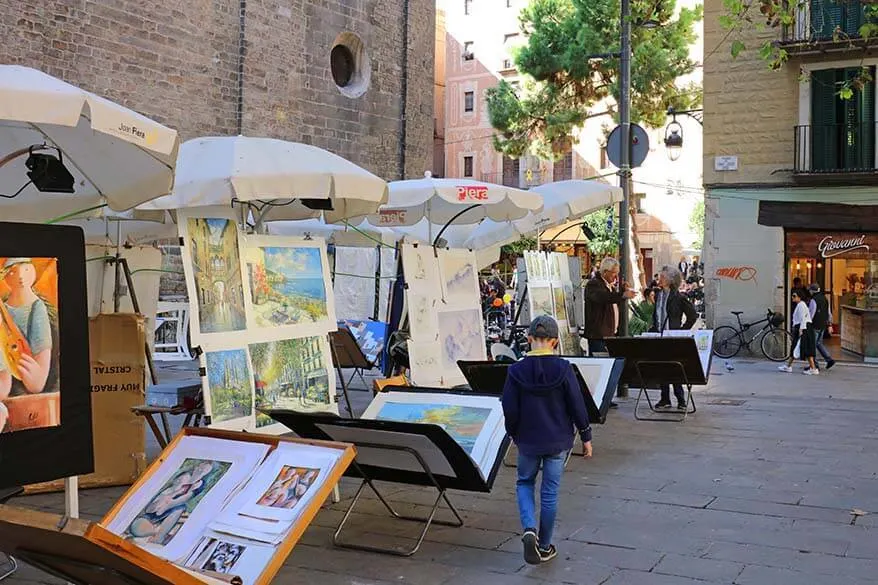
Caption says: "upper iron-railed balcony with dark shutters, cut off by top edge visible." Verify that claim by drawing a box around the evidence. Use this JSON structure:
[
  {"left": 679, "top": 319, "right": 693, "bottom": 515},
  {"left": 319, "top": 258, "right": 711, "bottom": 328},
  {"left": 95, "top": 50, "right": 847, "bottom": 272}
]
[{"left": 781, "top": 0, "right": 876, "bottom": 54}]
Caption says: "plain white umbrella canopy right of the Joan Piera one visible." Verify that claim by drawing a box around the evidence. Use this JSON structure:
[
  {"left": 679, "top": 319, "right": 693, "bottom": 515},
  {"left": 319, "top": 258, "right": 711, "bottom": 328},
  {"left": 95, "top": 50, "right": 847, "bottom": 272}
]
[{"left": 141, "top": 136, "right": 387, "bottom": 223}]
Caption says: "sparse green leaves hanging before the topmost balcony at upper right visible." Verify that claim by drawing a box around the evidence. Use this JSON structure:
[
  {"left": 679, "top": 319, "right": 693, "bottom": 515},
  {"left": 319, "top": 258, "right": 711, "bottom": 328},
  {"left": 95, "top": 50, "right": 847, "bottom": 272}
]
[{"left": 719, "top": 0, "right": 878, "bottom": 90}]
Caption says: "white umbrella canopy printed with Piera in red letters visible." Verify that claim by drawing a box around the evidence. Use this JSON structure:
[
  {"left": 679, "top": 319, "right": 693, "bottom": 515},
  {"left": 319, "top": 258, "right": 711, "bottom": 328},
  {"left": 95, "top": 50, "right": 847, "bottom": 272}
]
[{"left": 368, "top": 176, "right": 543, "bottom": 229}]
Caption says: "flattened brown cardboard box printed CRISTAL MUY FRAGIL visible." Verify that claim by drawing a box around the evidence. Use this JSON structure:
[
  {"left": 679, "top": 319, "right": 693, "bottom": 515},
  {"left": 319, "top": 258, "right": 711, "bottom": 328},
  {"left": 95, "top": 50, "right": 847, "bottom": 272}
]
[{"left": 26, "top": 313, "right": 146, "bottom": 493}]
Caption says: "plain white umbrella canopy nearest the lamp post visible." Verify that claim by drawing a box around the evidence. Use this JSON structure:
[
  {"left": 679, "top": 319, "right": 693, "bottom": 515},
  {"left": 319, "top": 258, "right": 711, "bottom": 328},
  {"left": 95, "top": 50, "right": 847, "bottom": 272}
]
[{"left": 463, "top": 180, "right": 622, "bottom": 249}]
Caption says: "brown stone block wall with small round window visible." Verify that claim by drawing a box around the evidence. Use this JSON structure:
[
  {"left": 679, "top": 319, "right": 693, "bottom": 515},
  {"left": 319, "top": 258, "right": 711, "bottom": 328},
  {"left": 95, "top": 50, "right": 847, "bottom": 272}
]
[{"left": 0, "top": 0, "right": 435, "bottom": 180}]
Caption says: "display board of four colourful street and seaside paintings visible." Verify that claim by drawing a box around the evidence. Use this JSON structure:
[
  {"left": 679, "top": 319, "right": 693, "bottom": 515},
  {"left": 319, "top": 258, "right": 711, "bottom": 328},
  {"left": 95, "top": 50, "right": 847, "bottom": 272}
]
[{"left": 178, "top": 208, "right": 338, "bottom": 433}]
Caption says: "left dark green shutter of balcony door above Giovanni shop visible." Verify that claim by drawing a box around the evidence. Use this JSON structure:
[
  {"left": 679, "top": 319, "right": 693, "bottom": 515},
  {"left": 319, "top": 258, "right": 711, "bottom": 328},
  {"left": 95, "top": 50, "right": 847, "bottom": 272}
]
[{"left": 810, "top": 69, "right": 841, "bottom": 172}]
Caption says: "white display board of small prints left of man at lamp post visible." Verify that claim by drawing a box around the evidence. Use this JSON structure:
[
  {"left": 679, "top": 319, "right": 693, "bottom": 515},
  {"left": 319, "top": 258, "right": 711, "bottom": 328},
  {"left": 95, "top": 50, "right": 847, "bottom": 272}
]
[{"left": 518, "top": 251, "right": 582, "bottom": 356}]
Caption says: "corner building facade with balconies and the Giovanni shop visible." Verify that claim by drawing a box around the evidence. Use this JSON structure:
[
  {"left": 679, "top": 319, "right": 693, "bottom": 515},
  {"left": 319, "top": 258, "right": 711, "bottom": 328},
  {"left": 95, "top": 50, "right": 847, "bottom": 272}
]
[{"left": 704, "top": 0, "right": 878, "bottom": 359}]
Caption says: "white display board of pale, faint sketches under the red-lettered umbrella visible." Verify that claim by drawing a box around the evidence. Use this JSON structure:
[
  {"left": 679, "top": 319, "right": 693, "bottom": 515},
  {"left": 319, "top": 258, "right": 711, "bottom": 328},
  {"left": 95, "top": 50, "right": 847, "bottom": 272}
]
[{"left": 402, "top": 244, "right": 487, "bottom": 388}]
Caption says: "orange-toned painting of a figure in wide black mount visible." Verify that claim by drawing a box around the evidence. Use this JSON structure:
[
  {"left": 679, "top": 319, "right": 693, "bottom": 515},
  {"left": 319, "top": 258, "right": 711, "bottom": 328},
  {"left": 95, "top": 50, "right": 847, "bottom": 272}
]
[{"left": 0, "top": 222, "right": 94, "bottom": 487}]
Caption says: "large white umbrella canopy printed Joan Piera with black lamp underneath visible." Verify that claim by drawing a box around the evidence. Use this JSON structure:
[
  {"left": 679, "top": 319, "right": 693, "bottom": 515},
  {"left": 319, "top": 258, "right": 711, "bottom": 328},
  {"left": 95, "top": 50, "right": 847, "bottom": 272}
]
[{"left": 0, "top": 65, "right": 179, "bottom": 222}]
